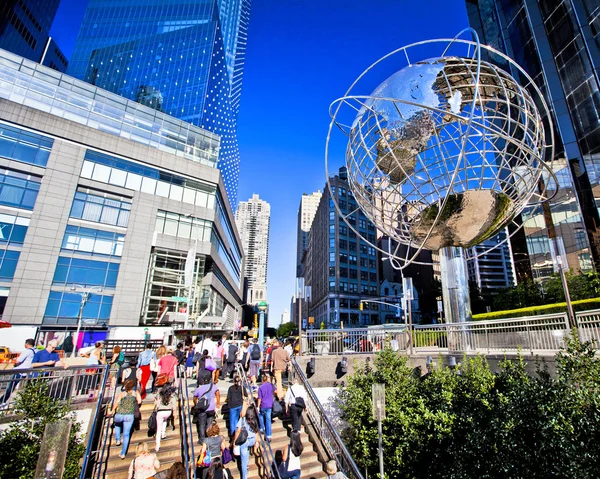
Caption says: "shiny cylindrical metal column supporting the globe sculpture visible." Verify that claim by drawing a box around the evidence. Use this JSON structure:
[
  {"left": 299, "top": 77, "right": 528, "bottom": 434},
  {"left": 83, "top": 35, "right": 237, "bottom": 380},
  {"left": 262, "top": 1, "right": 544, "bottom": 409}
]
[{"left": 439, "top": 246, "right": 471, "bottom": 351}]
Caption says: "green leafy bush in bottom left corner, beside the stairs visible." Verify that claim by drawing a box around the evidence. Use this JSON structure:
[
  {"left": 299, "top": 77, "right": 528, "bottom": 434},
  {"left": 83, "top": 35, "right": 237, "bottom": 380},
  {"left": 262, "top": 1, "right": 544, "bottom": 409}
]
[{"left": 0, "top": 380, "right": 85, "bottom": 479}]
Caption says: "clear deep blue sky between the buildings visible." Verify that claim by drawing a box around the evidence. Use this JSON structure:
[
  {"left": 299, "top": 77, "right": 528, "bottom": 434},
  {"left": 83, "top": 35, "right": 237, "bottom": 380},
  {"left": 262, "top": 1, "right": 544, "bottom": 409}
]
[{"left": 51, "top": 0, "right": 468, "bottom": 326}]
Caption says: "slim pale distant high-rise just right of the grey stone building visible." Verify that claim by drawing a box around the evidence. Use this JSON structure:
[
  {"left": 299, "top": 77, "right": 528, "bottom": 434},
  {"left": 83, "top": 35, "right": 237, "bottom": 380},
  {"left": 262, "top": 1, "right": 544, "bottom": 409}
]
[{"left": 235, "top": 194, "right": 271, "bottom": 304}]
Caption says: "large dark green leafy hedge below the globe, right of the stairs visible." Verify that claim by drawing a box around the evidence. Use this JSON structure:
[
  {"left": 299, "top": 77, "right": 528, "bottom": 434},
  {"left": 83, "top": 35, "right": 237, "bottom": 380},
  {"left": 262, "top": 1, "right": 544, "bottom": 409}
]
[{"left": 338, "top": 334, "right": 600, "bottom": 479}]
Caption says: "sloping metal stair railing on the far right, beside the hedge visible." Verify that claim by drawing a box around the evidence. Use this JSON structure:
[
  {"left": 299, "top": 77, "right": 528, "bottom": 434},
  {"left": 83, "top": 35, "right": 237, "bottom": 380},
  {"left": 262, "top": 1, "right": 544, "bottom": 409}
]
[{"left": 290, "top": 358, "right": 364, "bottom": 479}]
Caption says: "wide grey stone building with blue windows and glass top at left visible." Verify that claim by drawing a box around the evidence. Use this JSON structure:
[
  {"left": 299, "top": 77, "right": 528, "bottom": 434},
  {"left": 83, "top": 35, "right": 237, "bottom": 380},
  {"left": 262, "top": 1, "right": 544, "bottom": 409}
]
[{"left": 0, "top": 50, "right": 242, "bottom": 332}]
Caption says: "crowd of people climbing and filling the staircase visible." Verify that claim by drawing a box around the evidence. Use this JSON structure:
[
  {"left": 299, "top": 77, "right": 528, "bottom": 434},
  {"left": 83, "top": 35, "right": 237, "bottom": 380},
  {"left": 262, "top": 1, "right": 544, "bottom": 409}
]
[{"left": 0, "top": 335, "right": 352, "bottom": 479}]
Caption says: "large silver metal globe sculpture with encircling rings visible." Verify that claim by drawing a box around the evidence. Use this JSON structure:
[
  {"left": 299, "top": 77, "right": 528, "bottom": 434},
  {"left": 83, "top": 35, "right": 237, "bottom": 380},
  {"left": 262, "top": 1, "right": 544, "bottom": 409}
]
[{"left": 326, "top": 29, "right": 555, "bottom": 322}]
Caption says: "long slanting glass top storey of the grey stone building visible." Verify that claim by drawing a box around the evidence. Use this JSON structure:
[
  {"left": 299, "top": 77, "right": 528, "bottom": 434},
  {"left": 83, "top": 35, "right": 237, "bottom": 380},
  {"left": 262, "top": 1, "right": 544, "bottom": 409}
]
[{"left": 0, "top": 50, "right": 219, "bottom": 167}]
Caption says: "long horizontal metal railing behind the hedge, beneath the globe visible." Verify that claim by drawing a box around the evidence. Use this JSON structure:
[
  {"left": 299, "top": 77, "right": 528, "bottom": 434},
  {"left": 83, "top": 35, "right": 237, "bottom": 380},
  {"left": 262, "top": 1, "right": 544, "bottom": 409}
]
[{"left": 302, "top": 310, "right": 584, "bottom": 355}]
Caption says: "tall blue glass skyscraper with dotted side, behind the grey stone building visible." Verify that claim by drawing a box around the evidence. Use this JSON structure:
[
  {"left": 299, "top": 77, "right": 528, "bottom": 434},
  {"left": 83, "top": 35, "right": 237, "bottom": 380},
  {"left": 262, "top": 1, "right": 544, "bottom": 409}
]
[{"left": 68, "top": 0, "right": 250, "bottom": 205}]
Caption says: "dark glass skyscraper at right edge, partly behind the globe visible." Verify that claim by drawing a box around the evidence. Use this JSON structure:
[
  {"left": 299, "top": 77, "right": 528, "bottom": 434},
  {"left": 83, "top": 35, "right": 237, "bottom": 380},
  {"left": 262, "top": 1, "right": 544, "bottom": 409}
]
[{"left": 466, "top": 0, "right": 600, "bottom": 279}]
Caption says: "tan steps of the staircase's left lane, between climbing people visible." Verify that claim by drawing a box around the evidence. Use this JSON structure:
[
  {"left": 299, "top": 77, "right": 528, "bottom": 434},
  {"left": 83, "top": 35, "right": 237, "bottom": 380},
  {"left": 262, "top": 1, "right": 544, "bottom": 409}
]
[{"left": 103, "top": 400, "right": 181, "bottom": 479}]
